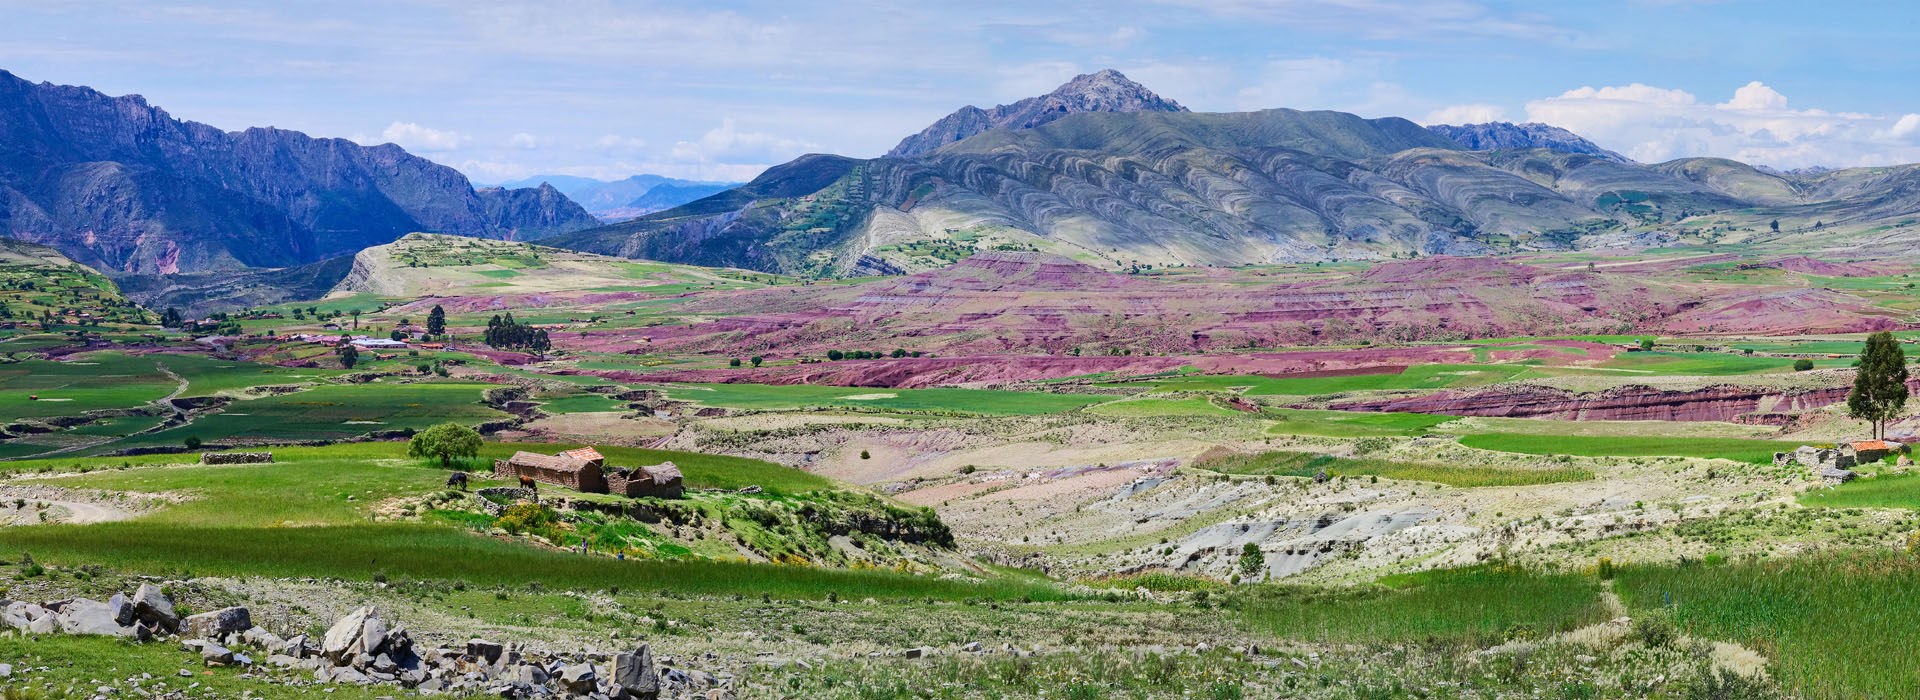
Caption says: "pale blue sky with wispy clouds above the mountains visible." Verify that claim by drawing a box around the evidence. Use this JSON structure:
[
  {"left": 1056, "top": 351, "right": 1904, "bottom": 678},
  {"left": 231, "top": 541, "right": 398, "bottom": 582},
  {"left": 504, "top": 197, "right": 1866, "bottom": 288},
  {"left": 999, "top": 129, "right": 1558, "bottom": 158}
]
[{"left": 0, "top": 0, "right": 1920, "bottom": 182}]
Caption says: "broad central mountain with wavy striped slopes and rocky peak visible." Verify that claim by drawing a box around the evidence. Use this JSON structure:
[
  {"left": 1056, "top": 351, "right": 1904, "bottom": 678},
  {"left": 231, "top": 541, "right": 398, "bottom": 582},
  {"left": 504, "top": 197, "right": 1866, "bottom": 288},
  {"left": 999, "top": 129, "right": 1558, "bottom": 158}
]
[{"left": 549, "top": 71, "right": 1920, "bottom": 276}]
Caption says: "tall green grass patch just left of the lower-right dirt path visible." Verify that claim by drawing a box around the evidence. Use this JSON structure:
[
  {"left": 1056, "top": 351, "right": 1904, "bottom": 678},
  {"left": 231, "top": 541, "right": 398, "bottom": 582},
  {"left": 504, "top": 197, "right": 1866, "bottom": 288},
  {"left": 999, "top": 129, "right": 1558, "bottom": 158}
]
[{"left": 1238, "top": 566, "right": 1607, "bottom": 644}]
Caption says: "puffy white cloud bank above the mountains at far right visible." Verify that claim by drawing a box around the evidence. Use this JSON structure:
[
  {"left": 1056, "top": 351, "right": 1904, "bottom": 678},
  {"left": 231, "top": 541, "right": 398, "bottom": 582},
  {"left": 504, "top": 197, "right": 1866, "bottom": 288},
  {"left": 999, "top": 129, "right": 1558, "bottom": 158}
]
[{"left": 1526, "top": 81, "right": 1920, "bottom": 169}]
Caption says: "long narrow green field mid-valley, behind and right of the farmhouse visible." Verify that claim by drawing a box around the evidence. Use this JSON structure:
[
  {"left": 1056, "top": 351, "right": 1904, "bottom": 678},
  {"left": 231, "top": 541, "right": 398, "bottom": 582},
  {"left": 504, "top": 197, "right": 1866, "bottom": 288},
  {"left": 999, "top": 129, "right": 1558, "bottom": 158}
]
[{"left": 660, "top": 384, "right": 1108, "bottom": 416}]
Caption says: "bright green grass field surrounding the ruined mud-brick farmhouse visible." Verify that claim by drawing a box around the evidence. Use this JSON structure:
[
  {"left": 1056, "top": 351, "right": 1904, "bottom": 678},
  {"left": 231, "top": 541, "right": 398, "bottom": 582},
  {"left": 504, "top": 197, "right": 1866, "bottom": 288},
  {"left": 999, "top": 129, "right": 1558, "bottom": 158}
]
[{"left": 0, "top": 443, "right": 1066, "bottom": 600}]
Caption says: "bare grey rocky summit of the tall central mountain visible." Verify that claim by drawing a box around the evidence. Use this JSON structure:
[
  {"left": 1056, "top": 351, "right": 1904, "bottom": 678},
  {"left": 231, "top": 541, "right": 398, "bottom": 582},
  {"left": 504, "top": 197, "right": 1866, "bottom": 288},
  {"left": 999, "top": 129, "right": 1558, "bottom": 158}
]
[{"left": 887, "top": 69, "right": 1187, "bottom": 157}]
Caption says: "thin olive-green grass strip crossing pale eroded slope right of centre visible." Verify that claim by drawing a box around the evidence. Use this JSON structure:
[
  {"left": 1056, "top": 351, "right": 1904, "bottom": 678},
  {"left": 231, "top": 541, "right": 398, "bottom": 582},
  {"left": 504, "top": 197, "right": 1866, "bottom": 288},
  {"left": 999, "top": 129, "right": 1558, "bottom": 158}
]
[{"left": 1196, "top": 451, "right": 1594, "bottom": 487}]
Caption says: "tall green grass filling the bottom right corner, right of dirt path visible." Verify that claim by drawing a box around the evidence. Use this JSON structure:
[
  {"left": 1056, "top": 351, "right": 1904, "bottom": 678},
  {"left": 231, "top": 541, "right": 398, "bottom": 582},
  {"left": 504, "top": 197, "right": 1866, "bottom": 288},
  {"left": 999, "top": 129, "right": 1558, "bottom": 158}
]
[{"left": 1615, "top": 552, "right": 1920, "bottom": 700}]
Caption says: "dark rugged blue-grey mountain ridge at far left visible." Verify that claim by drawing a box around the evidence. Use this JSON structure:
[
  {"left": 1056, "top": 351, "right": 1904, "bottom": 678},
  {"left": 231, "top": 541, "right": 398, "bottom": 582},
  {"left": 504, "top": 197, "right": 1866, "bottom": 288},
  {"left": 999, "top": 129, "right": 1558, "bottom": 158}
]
[{"left": 0, "top": 71, "right": 593, "bottom": 274}]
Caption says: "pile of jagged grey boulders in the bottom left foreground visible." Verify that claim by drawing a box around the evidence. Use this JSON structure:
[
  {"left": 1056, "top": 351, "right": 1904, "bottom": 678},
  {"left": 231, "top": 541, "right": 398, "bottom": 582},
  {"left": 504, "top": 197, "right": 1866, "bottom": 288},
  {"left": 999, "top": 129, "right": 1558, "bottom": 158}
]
[{"left": 0, "top": 583, "right": 706, "bottom": 700}]
